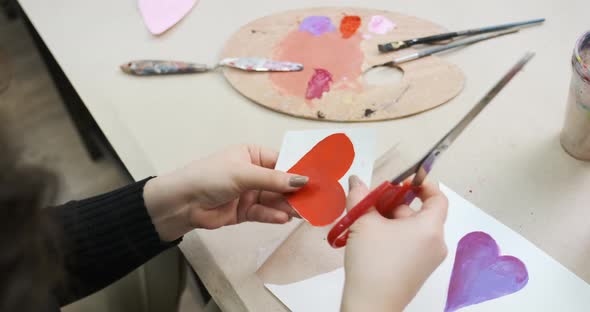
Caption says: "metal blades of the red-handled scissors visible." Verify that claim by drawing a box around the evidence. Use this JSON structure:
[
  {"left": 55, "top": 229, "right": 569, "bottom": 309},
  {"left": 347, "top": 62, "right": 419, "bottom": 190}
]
[{"left": 391, "top": 52, "right": 535, "bottom": 186}]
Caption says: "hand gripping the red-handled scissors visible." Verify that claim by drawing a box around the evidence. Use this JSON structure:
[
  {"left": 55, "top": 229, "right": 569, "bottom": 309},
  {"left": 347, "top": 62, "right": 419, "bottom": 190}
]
[{"left": 342, "top": 176, "right": 448, "bottom": 311}]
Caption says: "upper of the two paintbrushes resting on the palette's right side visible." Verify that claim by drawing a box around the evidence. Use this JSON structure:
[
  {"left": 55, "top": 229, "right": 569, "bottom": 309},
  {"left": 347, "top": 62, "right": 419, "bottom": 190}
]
[{"left": 378, "top": 18, "right": 545, "bottom": 53}]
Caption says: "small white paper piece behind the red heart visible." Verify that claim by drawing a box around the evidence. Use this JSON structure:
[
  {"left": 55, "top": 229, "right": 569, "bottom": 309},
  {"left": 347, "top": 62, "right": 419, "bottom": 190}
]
[{"left": 275, "top": 128, "right": 377, "bottom": 194}]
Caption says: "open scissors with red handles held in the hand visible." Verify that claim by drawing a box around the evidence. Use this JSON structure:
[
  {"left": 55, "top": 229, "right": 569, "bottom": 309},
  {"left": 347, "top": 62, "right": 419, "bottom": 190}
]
[{"left": 328, "top": 52, "right": 535, "bottom": 248}]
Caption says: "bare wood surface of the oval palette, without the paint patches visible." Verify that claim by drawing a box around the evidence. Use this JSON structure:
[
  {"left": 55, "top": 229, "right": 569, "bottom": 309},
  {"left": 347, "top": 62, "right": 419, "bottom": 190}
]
[{"left": 222, "top": 8, "right": 464, "bottom": 121}]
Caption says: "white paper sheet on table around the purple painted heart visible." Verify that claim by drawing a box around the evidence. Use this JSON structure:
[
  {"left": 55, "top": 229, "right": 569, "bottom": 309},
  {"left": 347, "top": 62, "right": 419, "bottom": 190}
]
[{"left": 266, "top": 185, "right": 590, "bottom": 312}]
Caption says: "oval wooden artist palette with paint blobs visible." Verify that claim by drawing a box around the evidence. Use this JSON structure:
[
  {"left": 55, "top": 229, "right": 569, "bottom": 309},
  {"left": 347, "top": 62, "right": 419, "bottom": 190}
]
[{"left": 222, "top": 8, "right": 464, "bottom": 121}]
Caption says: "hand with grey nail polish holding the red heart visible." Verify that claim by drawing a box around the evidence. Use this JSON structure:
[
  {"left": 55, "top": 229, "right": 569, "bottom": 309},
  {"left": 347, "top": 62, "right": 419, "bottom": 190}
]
[{"left": 144, "top": 145, "right": 308, "bottom": 241}]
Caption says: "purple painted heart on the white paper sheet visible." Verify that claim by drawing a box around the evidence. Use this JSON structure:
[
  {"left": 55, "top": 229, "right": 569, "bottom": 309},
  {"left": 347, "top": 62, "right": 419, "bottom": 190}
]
[{"left": 445, "top": 232, "right": 529, "bottom": 312}]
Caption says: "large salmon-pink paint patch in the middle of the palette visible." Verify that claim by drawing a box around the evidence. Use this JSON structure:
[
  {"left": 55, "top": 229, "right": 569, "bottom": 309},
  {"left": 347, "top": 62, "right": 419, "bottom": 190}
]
[{"left": 270, "top": 30, "right": 364, "bottom": 100}]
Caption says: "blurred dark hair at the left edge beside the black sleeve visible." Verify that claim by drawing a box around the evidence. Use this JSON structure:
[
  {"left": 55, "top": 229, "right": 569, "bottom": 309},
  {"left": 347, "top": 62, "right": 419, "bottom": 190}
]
[{"left": 0, "top": 125, "right": 61, "bottom": 311}]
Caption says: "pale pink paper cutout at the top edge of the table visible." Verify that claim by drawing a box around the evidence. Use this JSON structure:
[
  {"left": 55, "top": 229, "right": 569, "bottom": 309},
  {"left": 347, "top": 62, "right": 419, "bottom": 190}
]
[{"left": 138, "top": 0, "right": 198, "bottom": 35}]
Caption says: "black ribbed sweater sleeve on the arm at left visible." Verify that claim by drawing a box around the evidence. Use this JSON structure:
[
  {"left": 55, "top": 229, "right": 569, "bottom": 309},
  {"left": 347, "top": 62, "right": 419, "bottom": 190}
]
[{"left": 48, "top": 179, "right": 180, "bottom": 306}]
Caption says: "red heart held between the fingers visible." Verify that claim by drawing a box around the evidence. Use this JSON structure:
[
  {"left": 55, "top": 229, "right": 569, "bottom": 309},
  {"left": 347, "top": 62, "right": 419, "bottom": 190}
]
[{"left": 287, "top": 133, "right": 354, "bottom": 226}]
